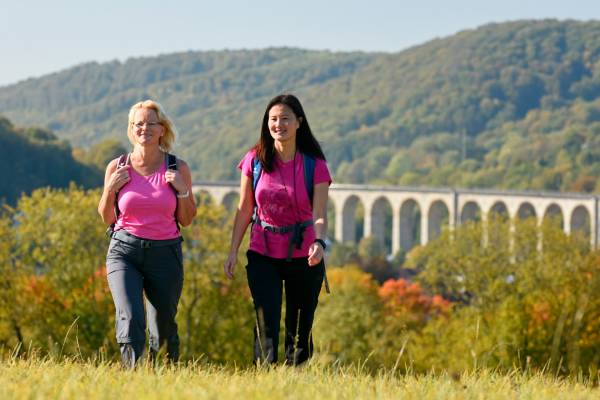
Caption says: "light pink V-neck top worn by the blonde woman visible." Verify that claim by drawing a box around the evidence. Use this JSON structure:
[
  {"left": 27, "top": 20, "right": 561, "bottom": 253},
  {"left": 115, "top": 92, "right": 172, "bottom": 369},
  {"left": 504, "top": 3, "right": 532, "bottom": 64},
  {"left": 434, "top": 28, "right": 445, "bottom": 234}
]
[{"left": 115, "top": 160, "right": 179, "bottom": 240}]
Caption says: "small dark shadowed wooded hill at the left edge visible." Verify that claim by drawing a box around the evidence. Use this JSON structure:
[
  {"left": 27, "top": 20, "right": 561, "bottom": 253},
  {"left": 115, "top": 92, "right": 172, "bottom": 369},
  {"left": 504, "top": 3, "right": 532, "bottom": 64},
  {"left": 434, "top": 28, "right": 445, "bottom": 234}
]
[{"left": 0, "top": 118, "right": 102, "bottom": 204}]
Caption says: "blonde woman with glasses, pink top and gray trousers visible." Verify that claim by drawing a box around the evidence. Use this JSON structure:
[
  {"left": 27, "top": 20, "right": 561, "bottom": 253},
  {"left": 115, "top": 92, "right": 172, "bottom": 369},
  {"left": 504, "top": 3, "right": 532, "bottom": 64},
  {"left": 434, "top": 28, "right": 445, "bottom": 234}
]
[{"left": 98, "top": 100, "right": 196, "bottom": 368}]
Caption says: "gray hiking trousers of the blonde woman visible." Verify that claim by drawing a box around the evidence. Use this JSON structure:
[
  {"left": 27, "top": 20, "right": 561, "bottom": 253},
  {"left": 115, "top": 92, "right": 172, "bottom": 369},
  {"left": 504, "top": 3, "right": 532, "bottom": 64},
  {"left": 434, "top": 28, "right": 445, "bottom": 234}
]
[{"left": 106, "top": 230, "right": 183, "bottom": 367}]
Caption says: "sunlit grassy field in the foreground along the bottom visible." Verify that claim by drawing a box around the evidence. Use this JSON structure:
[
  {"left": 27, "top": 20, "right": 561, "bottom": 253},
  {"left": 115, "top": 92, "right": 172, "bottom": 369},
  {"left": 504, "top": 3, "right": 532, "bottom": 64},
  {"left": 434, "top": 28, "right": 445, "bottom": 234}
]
[{"left": 0, "top": 359, "right": 600, "bottom": 400}]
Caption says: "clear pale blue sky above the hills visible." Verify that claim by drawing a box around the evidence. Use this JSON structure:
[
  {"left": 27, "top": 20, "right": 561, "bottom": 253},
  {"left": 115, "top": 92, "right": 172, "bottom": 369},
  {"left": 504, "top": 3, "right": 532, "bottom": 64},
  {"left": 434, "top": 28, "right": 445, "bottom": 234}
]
[{"left": 0, "top": 0, "right": 600, "bottom": 86}]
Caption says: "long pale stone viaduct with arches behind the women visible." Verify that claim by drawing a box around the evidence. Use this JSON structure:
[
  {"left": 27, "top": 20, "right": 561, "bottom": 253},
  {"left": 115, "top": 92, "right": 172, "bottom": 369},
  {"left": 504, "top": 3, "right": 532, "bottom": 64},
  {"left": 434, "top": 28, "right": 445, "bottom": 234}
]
[{"left": 193, "top": 182, "right": 600, "bottom": 254}]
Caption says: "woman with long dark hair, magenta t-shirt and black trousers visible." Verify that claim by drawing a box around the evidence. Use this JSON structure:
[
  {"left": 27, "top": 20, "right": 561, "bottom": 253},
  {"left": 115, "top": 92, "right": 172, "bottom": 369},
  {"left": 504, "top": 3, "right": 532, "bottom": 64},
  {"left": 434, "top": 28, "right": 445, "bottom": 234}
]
[{"left": 224, "top": 94, "right": 331, "bottom": 365}]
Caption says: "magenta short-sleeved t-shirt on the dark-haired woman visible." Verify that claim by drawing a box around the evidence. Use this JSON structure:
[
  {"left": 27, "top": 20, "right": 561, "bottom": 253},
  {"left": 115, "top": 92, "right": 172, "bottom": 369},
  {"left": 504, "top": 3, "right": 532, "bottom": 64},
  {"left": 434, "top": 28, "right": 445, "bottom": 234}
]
[{"left": 238, "top": 150, "right": 331, "bottom": 258}]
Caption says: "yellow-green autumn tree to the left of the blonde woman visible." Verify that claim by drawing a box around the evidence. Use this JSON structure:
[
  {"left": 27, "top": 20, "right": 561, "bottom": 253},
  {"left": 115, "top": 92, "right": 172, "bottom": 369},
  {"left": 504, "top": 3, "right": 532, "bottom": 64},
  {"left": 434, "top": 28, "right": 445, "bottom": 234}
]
[{"left": 14, "top": 185, "right": 114, "bottom": 354}]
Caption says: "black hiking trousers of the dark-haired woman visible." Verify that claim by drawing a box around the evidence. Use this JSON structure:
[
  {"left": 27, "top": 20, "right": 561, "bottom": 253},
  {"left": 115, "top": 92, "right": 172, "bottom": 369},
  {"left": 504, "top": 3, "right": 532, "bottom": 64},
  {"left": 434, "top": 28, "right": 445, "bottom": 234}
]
[{"left": 246, "top": 250, "right": 325, "bottom": 365}]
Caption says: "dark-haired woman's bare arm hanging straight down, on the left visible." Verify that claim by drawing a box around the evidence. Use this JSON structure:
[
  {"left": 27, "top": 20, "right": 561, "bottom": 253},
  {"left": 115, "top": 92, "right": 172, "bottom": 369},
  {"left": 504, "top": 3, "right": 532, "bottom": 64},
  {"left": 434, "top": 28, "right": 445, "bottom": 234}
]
[{"left": 223, "top": 174, "right": 254, "bottom": 278}]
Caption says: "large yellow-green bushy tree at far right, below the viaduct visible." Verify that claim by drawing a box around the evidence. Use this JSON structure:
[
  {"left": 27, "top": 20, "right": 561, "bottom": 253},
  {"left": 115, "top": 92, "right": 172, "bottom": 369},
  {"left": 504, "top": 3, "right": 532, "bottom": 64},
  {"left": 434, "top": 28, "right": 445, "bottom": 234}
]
[{"left": 414, "top": 218, "right": 600, "bottom": 373}]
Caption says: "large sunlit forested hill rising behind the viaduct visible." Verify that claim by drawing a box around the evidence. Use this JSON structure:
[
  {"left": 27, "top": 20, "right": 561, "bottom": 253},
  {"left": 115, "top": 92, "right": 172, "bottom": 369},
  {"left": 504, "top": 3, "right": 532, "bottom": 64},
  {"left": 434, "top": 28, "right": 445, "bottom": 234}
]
[{"left": 0, "top": 20, "right": 600, "bottom": 191}]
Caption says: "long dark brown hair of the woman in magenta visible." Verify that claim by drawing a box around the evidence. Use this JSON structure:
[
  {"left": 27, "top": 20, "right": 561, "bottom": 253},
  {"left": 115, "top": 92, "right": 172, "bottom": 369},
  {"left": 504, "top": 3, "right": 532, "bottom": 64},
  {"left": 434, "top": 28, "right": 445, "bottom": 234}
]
[{"left": 254, "top": 94, "right": 325, "bottom": 172}]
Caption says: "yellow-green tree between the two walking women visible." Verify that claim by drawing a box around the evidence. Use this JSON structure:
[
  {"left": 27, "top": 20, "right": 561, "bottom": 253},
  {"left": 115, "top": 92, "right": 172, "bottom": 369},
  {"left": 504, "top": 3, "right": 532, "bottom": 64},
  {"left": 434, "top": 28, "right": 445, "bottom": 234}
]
[{"left": 177, "top": 202, "right": 254, "bottom": 365}]
